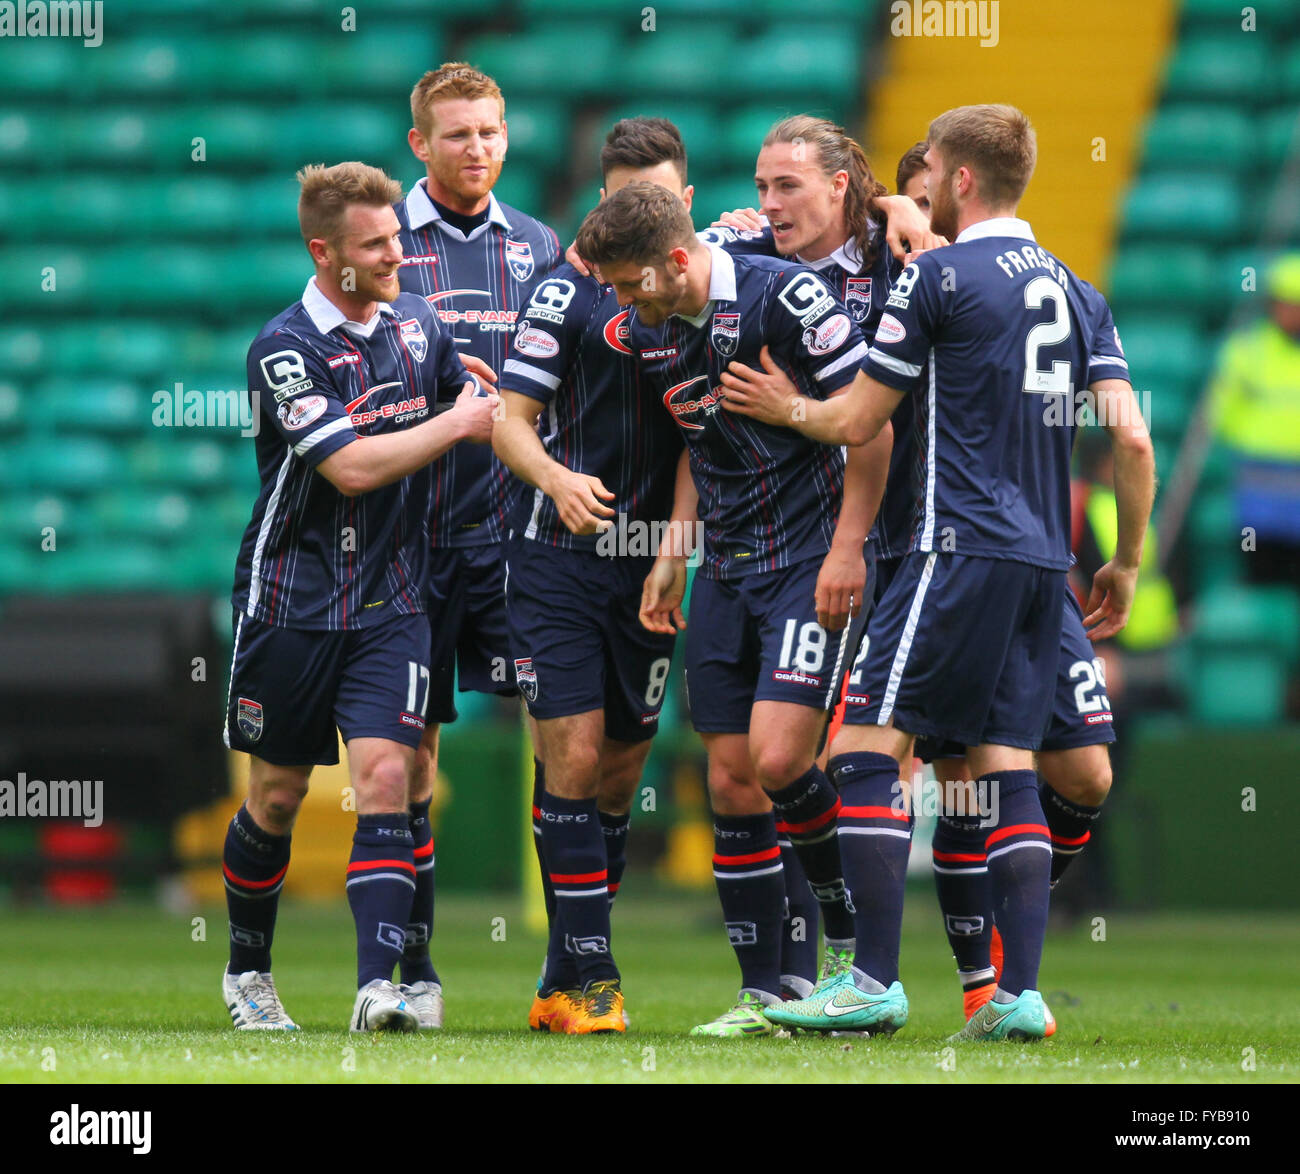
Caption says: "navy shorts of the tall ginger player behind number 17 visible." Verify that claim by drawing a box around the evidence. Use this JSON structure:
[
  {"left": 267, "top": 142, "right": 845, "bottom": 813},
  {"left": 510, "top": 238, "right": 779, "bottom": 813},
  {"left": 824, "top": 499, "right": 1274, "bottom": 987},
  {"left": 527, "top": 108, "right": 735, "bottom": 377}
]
[{"left": 426, "top": 546, "right": 515, "bottom": 725}]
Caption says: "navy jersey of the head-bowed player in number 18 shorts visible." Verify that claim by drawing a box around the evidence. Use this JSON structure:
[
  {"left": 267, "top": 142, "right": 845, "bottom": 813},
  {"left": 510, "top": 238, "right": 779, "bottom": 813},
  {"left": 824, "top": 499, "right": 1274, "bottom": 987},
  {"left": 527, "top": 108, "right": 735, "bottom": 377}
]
[{"left": 628, "top": 246, "right": 867, "bottom": 579}]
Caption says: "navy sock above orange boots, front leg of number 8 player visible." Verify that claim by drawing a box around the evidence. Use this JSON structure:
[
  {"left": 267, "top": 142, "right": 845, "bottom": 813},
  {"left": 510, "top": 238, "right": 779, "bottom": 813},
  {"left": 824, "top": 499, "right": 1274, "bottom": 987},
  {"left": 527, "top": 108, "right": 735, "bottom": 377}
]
[{"left": 541, "top": 792, "right": 619, "bottom": 987}]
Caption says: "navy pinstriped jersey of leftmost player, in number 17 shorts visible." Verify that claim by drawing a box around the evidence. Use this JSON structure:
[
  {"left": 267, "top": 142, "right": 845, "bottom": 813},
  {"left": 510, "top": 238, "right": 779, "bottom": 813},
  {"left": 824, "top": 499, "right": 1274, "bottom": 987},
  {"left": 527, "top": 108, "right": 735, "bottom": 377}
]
[{"left": 234, "top": 278, "right": 469, "bottom": 631}]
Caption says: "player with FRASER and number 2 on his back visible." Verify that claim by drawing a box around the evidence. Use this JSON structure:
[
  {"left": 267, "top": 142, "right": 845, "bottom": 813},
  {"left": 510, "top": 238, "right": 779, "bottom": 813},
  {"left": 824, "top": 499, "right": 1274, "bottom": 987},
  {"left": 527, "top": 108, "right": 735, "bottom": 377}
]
[{"left": 727, "top": 107, "right": 1154, "bottom": 1039}]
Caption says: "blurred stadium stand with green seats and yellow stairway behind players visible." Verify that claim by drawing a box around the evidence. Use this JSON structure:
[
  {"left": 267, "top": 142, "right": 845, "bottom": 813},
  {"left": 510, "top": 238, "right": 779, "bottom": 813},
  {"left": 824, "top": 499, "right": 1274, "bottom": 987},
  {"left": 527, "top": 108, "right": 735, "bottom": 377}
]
[{"left": 0, "top": 0, "right": 1300, "bottom": 909}]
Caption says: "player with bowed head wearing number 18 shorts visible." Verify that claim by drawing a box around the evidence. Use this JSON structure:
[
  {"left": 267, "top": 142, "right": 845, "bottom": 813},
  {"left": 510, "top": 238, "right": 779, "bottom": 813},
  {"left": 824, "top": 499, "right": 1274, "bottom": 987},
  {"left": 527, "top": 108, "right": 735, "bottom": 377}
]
[{"left": 577, "top": 183, "right": 888, "bottom": 1037}]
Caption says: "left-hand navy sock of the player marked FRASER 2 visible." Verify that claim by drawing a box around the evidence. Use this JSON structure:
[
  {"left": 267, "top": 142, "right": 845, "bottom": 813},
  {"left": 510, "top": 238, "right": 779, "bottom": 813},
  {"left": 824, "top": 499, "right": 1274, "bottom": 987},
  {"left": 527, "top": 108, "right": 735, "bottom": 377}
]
[{"left": 829, "top": 750, "right": 911, "bottom": 987}]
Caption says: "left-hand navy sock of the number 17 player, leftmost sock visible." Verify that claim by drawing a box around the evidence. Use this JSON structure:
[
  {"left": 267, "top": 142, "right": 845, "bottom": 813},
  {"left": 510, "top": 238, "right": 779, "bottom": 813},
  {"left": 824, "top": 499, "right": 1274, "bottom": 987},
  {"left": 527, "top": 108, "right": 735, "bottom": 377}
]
[{"left": 221, "top": 806, "right": 290, "bottom": 974}]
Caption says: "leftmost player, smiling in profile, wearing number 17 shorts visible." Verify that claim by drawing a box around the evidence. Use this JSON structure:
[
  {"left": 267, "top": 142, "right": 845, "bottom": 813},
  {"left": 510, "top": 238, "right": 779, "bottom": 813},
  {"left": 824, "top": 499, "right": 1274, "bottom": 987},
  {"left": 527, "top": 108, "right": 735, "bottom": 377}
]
[{"left": 222, "top": 163, "right": 498, "bottom": 1031}]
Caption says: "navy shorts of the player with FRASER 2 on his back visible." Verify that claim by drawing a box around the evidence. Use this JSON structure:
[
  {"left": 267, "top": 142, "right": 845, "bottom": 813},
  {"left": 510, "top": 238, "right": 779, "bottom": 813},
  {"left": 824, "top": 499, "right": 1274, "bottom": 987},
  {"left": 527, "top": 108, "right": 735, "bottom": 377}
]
[{"left": 844, "top": 551, "right": 1066, "bottom": 750}]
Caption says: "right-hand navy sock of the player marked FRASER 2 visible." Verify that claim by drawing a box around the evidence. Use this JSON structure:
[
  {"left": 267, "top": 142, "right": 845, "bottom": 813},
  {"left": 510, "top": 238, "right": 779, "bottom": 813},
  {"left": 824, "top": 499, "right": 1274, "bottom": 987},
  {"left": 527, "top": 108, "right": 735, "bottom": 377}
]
[{"left": 976, "top": 771, "right": 1052, "bottom": 997}]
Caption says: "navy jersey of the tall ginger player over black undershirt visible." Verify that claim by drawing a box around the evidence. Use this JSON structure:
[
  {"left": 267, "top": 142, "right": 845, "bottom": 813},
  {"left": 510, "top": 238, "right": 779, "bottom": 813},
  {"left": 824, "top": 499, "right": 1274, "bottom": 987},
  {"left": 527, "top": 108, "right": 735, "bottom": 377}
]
[{"left": 394, "top": 179, "right": 564, "bottom": 546}]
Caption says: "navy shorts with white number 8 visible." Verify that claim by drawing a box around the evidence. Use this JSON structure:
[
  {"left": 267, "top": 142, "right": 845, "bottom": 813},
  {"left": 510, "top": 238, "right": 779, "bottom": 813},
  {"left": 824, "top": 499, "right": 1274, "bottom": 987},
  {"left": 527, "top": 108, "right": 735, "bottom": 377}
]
[{"left": 506, "top": 534, "right": 676, "bottom": 742}]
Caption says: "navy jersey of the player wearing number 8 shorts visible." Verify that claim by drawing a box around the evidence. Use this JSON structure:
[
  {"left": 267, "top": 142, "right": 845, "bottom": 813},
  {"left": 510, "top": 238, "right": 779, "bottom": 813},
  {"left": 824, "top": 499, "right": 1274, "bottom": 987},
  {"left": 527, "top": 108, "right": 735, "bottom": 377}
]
[{"left": 501, "top": 264, "right": 681, "bottom": 554}]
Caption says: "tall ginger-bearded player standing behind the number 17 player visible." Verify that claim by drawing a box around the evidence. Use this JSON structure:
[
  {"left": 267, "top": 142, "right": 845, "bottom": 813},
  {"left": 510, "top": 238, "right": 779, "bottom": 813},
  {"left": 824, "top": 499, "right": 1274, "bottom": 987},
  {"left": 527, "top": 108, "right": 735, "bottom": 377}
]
[{"left": 394, "top": 62, "right": 562, "bottom": 1027}]
